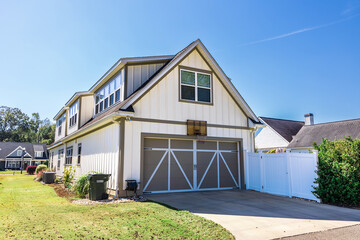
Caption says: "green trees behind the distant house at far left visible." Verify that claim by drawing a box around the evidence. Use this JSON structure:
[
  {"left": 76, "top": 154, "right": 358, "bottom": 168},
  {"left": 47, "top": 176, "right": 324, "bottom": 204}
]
[{"left": 0, "top": 106, "right": 55, "bottom": 144}]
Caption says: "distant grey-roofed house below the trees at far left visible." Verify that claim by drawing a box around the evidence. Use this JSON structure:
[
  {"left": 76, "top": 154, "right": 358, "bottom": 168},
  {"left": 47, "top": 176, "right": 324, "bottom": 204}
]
[{"left": 0, "top": 142, "right": 49, "bottom": 170}]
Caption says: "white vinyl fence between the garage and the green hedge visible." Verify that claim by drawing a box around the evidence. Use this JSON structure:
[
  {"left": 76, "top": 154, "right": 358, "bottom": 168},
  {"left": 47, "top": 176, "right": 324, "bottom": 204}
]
[{"left": 245, "top": 152, "right": 319, "bottom": 202}]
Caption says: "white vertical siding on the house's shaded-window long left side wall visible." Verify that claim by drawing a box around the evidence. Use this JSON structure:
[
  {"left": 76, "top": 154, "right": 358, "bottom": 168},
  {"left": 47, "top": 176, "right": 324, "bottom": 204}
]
[{"left": 50, "top": 124, "right": 120, "bottom": 190}]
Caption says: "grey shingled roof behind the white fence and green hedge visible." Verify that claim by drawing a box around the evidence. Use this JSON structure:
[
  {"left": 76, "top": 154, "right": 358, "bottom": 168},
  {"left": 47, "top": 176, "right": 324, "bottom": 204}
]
[{"left": 288, "top": 119, "right": 360, "bottom": 148}]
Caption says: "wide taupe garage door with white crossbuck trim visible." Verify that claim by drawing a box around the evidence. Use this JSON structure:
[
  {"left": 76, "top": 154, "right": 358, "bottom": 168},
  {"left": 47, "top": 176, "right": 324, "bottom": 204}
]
[{"left": 143, "top": 138, "right": 240, "bottom": 192}]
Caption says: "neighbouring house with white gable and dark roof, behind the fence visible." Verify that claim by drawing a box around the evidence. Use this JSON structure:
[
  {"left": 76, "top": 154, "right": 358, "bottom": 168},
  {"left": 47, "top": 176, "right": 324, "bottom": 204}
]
[{"left": 255, "top": 117, "right": 304, "bottom": 151}]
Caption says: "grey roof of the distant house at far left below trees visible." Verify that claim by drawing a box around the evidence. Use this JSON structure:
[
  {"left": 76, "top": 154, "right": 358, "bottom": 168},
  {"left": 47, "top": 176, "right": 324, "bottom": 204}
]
[{"left": 0, "top": 142, "right": 48, "bottom": 159}]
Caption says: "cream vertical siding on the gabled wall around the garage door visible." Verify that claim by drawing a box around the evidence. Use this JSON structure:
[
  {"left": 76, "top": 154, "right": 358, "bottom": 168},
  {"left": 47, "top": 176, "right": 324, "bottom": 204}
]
[{"left": 124, "top": 51, "right": 254, "bottom": 187}]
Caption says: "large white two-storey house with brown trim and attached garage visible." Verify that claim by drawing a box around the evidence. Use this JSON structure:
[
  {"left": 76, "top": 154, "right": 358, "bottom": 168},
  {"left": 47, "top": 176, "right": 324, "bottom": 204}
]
[{"left": 49, "top": 39, "right": 260, "bottom": 195}]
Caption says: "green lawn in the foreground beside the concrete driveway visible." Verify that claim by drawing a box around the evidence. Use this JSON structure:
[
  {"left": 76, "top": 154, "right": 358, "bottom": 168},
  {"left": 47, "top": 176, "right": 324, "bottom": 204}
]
[{"left": 0, "top": 175, "right": 233, "bottom": 239}]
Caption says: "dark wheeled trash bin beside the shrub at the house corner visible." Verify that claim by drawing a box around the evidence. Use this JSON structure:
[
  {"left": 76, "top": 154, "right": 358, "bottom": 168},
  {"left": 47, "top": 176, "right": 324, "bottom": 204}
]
[{"left": 88, "top": 174, "right": 111, "bottom": 201}]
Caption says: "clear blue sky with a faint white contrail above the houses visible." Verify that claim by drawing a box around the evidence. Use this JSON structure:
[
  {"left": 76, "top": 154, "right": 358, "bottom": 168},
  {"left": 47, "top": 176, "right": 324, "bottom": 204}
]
[{"left": 0, "top": 0, "right": 360, "bottom": 123}]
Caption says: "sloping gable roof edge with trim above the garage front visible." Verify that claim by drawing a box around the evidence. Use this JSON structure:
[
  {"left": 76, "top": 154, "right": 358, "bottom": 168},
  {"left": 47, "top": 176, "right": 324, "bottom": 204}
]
[{"left": 122, "top": 39, "right": 258, "bottom": 121}]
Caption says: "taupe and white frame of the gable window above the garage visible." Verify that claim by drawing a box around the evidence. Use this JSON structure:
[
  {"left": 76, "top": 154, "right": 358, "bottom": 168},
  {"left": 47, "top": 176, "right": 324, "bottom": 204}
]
[{"left": 179, "top": 66, "right": 214, "bottom": 105}]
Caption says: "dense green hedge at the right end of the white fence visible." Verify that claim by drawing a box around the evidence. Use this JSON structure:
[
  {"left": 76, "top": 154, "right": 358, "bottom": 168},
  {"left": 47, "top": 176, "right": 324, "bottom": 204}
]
[{"left": 313, "top": 137, "right": 360, "bottom": 206}]
